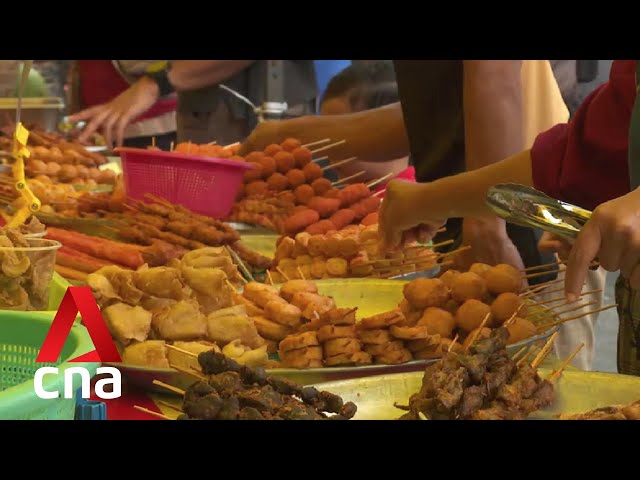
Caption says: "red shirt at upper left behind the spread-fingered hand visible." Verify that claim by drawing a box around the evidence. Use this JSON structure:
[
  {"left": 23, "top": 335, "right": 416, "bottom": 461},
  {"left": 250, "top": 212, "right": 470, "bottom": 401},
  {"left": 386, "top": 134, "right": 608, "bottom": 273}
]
[{"left": 78, "top": 60, "right": 178, "bottom": 122}]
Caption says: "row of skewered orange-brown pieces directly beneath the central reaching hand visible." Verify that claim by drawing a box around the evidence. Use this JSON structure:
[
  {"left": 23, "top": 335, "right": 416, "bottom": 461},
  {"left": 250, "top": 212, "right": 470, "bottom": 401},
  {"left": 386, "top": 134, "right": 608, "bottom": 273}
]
[{"left": 270, "top": 223, "right": 437, "bottom": 283}]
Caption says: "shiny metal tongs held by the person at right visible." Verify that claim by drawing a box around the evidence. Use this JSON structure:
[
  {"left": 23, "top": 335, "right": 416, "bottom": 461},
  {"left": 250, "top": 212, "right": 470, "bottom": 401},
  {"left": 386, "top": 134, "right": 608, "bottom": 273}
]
[{"left": 486, "top": 183, "right": 591, "bottom": 241}]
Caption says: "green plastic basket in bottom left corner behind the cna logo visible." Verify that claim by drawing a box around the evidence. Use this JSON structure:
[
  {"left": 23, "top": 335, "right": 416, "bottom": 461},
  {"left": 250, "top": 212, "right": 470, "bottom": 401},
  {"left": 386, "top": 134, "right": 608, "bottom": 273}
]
[{"left": 0, "top": 310, "right": 99, "bottom": 420}]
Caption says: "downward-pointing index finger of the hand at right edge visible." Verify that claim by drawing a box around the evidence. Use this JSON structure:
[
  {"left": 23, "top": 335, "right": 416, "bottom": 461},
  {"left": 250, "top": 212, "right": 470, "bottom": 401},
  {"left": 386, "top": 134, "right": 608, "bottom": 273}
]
[{"left": 564, "top": 221, "right": 602, "bottom": 301}]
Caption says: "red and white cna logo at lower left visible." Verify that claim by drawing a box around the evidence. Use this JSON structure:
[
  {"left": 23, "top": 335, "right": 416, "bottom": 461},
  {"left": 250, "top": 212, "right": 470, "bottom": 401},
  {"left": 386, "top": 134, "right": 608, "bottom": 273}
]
[{"left": 34, "top": 287, "right": 122, "bottom": 400}]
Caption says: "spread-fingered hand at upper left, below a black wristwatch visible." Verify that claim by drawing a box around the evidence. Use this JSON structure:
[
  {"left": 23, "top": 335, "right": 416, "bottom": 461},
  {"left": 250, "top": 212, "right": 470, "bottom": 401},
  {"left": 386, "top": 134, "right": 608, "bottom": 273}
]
[{"left": 69, "top": 77, "right": 160, "bottom": 147}]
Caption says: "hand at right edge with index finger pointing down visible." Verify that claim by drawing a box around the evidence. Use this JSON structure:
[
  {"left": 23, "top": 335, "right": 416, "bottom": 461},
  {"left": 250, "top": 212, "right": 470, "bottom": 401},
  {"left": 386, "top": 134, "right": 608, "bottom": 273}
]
[{"left": 565, "top": 189, "right": 640, "bottom": 301}]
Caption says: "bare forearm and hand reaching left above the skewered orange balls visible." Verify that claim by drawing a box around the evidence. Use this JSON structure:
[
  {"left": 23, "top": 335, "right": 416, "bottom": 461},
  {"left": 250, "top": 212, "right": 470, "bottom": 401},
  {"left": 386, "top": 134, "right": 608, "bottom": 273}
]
[{"left": 239, "top": 103, "right": 409, "bottom": 162}]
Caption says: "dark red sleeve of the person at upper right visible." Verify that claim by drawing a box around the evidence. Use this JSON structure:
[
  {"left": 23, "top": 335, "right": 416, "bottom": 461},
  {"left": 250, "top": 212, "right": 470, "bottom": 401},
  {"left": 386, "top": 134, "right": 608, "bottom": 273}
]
[{"left": 531, "top": 60, "right": 636, "bottom": 210}]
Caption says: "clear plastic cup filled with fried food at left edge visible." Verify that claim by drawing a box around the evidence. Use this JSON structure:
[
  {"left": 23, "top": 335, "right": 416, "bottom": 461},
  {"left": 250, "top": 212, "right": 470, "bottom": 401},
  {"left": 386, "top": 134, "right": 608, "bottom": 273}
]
[{"left": 0, "top": 224, "right": 56, "bottom": 311}]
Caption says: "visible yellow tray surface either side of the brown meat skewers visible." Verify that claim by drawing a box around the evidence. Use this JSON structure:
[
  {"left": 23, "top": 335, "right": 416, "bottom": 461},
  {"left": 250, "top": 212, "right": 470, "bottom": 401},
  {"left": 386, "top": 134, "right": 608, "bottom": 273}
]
[{"left": 308, "top": 369, "right": 640, "bottom": 420}]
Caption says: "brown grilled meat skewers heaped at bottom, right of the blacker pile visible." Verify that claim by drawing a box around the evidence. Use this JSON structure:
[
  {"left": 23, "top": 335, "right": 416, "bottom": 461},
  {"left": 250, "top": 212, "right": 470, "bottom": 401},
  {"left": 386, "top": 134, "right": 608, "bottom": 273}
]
[{"left": 399, "top": 328, "right": 554, "bottom": 420}]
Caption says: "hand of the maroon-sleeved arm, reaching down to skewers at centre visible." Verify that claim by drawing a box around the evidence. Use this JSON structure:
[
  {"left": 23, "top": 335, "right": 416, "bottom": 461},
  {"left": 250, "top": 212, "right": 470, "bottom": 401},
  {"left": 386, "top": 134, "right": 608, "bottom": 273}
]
[{"left": 378, "top": 180, "right": 446, "bottom": 250}]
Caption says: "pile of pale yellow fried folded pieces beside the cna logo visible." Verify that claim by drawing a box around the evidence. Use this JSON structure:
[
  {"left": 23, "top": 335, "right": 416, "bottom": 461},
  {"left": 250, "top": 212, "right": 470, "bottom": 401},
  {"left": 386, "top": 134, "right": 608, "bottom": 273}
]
[{"left": 87, "top": 248, "right": 267, "bottom": 368}]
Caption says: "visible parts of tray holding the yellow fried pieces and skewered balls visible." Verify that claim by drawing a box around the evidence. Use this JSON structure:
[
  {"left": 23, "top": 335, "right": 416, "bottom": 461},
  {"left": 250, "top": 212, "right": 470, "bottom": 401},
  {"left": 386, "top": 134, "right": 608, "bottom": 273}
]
[{"left": 113, "top": 278, "right": 559, "bottom": 393}]
